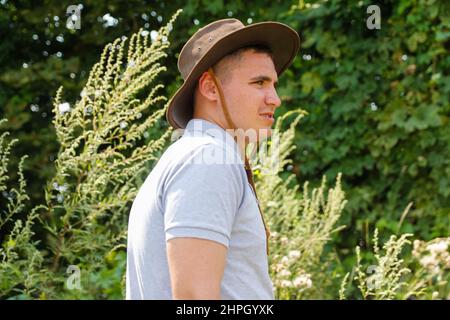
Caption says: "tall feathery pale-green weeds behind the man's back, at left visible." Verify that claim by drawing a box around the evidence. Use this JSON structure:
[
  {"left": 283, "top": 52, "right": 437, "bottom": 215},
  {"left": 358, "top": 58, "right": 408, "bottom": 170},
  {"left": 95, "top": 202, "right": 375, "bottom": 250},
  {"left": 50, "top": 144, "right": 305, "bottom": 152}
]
[{"left": 0, "top": 12, "right": 178, "bottom": 299}]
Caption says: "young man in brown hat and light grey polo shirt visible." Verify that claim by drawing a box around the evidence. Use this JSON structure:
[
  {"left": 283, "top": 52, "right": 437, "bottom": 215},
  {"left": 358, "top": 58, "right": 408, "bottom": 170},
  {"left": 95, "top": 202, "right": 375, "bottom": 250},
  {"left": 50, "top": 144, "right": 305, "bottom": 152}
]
[{"left": 126, "top": 19, "right": 300, "bottom": 299}]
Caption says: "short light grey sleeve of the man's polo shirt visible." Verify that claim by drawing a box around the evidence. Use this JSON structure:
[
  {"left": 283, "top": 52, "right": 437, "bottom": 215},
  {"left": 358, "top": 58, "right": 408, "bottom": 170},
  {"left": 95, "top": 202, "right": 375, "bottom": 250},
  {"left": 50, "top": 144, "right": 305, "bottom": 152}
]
[{"left": 163, "top": 145, "right": 244, "bottom": 248}]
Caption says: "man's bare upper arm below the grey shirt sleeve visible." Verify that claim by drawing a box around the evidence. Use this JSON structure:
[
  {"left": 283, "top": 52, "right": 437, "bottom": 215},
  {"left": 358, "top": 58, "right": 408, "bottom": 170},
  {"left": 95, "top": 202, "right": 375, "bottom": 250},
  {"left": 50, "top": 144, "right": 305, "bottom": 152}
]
[{"left": 167, "top": 238, "right": 227, "bottom": 300}]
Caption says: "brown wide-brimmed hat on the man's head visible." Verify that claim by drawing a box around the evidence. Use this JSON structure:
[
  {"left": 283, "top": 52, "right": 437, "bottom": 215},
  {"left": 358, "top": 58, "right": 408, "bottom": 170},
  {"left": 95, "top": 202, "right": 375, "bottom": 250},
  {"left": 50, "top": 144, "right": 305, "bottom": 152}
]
[{"left": 166, "top": 19, "right": 300, "bottom": 129}]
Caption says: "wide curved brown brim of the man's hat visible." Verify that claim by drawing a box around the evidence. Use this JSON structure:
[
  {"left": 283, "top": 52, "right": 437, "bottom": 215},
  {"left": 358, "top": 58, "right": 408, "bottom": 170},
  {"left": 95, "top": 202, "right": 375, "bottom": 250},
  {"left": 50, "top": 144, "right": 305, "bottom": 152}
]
[{"left": 166, "top": 21, "right": 300, "bottom": 129}]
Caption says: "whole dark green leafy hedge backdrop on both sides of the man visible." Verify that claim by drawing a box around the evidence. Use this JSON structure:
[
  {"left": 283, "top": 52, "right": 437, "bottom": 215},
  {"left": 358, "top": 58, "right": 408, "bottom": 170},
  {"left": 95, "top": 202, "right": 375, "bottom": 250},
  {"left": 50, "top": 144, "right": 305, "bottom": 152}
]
[{"left": 0, "top": 0, "right": 450, "bottom": 296}]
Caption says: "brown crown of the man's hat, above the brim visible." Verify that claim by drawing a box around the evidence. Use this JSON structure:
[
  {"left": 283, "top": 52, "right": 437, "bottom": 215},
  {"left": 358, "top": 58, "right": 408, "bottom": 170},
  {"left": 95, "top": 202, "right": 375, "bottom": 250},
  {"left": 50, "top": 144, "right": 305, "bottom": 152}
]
[{"left": 178, "top": 19, "right": 245, "bottom": 80}]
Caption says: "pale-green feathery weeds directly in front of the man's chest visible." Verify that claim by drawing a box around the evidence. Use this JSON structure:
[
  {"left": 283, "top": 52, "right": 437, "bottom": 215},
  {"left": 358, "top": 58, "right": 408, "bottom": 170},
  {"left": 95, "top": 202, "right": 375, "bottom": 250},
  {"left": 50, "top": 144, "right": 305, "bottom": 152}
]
[{"left": 253, "top": 110, "right": 346, "bottom": 299}]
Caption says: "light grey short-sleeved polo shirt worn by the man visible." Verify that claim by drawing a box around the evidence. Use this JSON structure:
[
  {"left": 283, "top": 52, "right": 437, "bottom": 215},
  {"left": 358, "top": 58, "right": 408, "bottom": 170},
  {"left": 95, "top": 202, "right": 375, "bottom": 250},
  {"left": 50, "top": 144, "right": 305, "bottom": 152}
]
[{"left": 126, "top": 119, "right": 274, "bottom": 300}]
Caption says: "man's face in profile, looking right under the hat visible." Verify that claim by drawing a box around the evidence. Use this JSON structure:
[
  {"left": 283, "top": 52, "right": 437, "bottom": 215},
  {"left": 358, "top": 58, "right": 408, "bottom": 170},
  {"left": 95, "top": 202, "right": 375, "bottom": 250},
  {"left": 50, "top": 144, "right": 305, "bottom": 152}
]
[{"left": 221, "top": 50, "right": 281, "bottom": 141}]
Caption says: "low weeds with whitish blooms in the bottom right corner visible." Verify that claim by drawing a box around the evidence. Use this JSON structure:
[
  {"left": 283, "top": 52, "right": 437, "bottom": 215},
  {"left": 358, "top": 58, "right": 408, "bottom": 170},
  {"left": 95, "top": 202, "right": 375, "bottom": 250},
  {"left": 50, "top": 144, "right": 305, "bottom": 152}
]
[{"left": 339, "top": 229, "right": 450, "bottom": 300}]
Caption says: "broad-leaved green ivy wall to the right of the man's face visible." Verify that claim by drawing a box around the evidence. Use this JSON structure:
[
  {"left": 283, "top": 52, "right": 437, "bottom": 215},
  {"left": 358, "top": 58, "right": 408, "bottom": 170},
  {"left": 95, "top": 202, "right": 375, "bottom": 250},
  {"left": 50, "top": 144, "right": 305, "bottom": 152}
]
[{"left": 280, "top": 0, "right": 450, "bottom": 276}]
